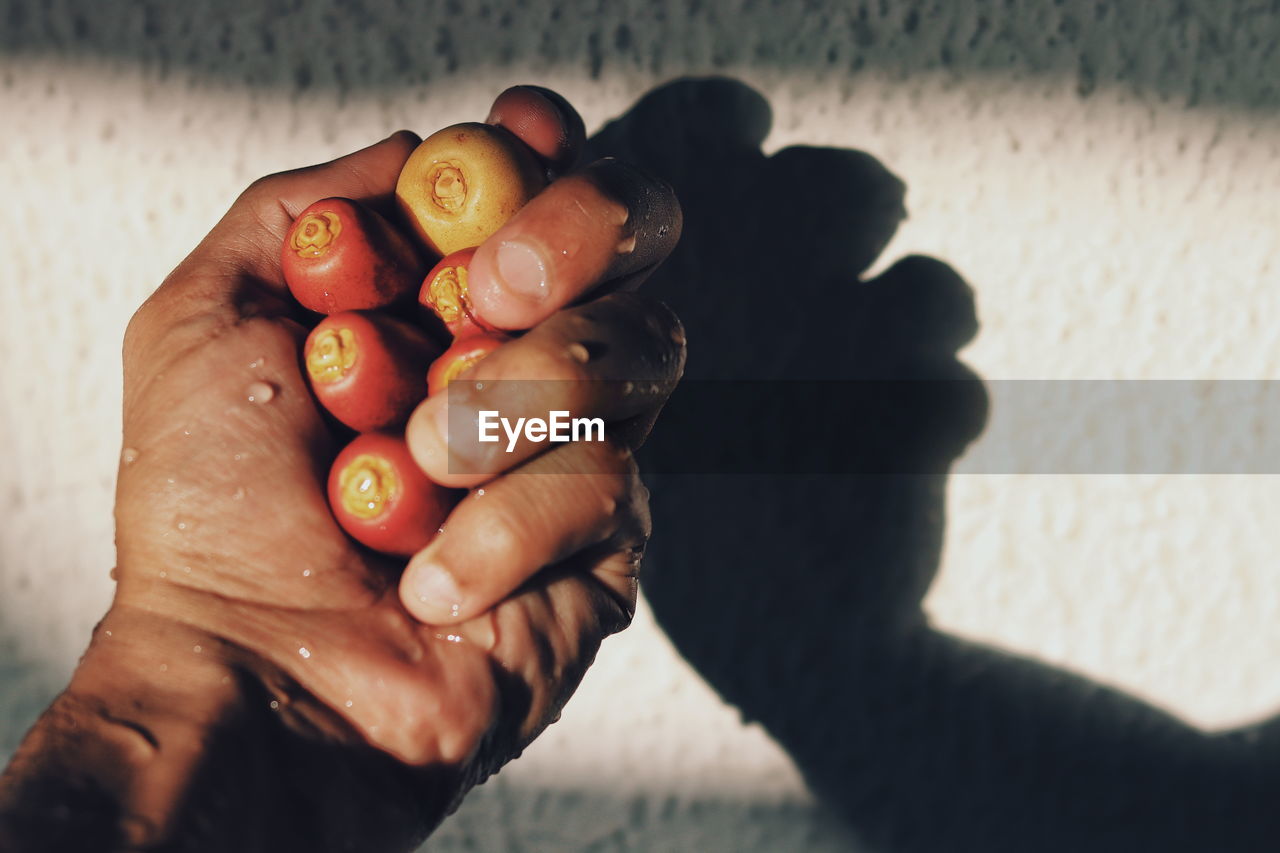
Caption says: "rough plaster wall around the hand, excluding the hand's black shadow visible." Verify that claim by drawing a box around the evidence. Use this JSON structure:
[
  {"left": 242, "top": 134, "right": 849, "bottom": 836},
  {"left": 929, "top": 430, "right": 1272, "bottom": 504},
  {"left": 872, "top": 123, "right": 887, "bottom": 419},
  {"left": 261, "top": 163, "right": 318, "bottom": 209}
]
[{"left": 0, "top": 0, "right": 1280, "bottom": 852}]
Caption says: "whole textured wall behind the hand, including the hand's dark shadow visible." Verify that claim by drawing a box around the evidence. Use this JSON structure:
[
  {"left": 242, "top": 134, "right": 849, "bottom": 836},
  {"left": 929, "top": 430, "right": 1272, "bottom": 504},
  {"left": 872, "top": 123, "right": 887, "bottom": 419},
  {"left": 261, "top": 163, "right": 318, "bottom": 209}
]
[{"left": 0, "top": 0, "right": 1280, "bottom": 852}]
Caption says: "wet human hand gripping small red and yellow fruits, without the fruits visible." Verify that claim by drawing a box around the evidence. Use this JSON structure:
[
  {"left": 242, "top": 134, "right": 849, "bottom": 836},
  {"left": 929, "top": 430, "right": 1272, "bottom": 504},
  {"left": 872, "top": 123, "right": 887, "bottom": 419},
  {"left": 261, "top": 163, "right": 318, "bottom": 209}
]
[{"left": 0, "top": 88, "right": 684, "bottom": 838}]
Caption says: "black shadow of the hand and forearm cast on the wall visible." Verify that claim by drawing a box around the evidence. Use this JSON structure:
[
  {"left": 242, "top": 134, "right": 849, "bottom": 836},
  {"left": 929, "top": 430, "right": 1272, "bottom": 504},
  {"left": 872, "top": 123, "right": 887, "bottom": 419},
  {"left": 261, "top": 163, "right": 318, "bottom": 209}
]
[{"left": 591, "top": 79, "right": 1280, "bottom": 853}]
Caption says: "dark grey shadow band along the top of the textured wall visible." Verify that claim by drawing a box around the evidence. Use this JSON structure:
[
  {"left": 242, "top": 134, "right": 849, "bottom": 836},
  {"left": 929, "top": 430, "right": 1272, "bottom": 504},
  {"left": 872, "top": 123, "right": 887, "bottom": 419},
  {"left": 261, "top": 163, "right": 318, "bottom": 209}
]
[{"left": 0, "top": 0, "right": 1280, "bottom": 111}]
